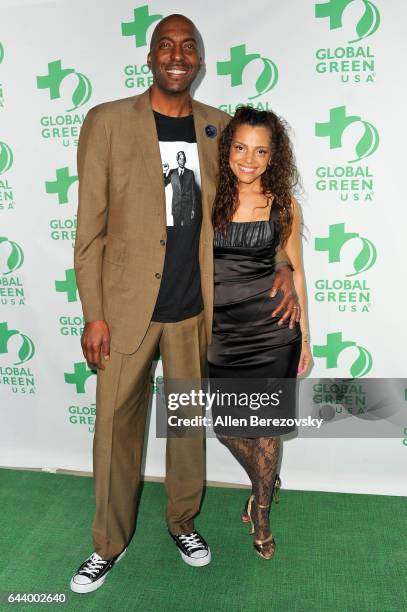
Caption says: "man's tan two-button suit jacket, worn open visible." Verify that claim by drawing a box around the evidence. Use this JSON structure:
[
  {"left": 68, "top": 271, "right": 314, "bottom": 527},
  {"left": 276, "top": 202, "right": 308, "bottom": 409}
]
[{"left": 75, "top": 91, "right": 230, "bottom": 354}]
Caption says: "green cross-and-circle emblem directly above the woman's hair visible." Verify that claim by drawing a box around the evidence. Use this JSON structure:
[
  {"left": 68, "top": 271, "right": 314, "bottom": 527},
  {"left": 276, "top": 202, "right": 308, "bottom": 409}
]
[{"left": 216, "top": 44, "right": 278, "bottom": 100}]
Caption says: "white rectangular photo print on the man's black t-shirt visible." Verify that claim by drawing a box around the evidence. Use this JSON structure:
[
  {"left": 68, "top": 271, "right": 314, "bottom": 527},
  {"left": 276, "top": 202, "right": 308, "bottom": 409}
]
[{"left": 159, "top": 141, "right": 201, "bottom": 227}]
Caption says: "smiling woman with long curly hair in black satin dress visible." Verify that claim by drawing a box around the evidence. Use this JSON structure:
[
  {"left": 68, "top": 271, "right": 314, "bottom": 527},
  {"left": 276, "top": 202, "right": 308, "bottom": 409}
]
[{"left": 208, "top": 107, "right": 311, "bottom": 559}]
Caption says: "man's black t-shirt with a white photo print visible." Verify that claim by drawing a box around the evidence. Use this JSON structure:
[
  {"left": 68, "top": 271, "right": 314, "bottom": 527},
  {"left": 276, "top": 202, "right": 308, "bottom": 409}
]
[{"left": 152, "top": 112, "right": 203, "bottom": 323}]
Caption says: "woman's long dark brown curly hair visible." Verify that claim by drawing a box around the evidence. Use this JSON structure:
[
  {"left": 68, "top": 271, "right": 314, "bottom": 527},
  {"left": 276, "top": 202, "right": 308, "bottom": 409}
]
[{"left": 212, "top": 106, "right": 299, "bottom": 246}]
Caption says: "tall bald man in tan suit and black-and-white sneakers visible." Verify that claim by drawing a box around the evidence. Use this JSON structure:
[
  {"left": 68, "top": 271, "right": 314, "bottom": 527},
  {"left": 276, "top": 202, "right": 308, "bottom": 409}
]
[{"left": 71, "top": 15, "right": 296, "bottom": 593}]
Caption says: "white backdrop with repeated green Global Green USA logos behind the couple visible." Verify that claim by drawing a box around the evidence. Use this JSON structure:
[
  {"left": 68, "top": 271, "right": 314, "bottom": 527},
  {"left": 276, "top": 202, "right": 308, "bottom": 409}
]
[{"left": 0, "top": 0, "right": 407, "bottom": 494}]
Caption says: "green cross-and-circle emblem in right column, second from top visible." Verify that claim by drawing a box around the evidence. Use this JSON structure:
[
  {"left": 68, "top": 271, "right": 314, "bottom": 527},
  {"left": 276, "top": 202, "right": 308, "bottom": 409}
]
[{"left": 315, "top": 106, "right": 379, "bottom": 164}]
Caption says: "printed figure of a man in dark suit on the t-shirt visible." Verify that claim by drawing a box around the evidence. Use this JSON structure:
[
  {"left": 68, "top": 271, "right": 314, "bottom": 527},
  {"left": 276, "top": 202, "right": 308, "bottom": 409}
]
[{"left": 164, "top": 151, "right": 201, "bottom": 227}]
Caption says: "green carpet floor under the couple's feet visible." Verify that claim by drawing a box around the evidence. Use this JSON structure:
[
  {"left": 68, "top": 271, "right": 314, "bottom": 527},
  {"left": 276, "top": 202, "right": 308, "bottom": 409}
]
[{"left": 0, "top": 469, "right": 407, "bottom": 612}]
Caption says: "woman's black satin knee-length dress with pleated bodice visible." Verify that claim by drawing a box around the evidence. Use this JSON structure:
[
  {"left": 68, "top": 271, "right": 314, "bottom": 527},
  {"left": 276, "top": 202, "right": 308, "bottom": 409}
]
[{"left": 208, "top": 207, "right": 301, "bottom": 437}]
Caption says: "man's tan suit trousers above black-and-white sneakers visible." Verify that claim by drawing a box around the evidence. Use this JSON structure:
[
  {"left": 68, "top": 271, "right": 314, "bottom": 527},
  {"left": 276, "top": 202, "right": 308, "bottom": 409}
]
[{"left": 92, "top": 312, "right": 207, "bottom": 559}]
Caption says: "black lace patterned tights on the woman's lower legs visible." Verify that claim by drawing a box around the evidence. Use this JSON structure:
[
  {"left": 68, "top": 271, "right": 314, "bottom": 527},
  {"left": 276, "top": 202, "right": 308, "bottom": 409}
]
[{"left": 218, "top": 436, "right": 280, "bottom": 540}]
